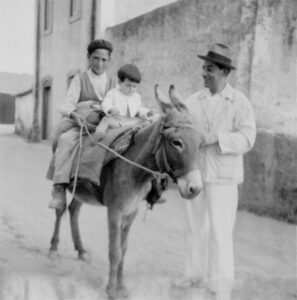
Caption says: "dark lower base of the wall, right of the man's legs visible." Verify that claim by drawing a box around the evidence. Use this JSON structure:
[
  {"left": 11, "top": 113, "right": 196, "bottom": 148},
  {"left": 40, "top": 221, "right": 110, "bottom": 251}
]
[{"left": 239, "top": 130, "right": 297, "bottom": 224}]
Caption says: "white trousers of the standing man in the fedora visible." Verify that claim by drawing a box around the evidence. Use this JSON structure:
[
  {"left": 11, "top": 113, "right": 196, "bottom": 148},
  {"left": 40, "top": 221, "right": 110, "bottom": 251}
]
[{"left": 185, "top": 183, "right": 238, "bottom": 299}]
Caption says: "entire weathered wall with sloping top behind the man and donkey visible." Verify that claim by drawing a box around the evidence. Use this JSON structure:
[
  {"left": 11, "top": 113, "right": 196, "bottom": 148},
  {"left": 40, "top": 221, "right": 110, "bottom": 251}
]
[{"left": 106, "top": 0, "right": 297, "bottom": 222}]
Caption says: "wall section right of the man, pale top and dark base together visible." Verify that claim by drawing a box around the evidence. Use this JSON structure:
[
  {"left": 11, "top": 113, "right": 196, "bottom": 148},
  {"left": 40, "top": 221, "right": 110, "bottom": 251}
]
[{"left": 240, "top": 0, "right": 297, "bottom": 223}]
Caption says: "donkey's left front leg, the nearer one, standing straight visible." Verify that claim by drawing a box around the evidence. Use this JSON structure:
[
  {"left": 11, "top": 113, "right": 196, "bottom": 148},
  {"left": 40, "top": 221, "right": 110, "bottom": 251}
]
[{"left": 106, "top": 208, "right": 122, "bottom": 299}]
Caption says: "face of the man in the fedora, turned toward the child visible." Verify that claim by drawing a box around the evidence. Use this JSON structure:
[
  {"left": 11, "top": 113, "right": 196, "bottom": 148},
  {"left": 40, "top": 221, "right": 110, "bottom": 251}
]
[{"left": 202, "top": 60, "right": 225, "bottom": 89}]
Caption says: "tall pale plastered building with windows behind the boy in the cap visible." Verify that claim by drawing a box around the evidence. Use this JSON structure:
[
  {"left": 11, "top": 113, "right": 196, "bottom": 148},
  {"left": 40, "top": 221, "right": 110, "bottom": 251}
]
[{"left": 32, "top": 0, "right": 174, "bottom": 140}]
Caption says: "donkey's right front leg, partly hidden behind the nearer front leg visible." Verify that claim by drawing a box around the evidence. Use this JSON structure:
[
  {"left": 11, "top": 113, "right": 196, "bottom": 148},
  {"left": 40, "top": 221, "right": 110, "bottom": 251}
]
[{"left": 117, "top": 210, "right": 137, "bottom": 297}]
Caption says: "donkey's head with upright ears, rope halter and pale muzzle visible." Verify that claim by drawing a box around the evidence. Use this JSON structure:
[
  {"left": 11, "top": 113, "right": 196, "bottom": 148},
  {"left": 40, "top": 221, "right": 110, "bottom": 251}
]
[{"left": 155, "top": 85, "right": 202, "bottom": 199}]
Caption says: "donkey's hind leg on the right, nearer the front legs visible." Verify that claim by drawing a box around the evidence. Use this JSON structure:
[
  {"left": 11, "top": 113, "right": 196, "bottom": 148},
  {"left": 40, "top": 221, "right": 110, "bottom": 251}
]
[{"left": 69, "top": 198, "right": 90, "bottom": 261}]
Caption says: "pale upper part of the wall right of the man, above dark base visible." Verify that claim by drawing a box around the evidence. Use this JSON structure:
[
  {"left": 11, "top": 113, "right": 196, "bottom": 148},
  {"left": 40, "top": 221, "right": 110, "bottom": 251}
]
[{"left": 250, "top": 0, "right": 297, "bottom": 135}]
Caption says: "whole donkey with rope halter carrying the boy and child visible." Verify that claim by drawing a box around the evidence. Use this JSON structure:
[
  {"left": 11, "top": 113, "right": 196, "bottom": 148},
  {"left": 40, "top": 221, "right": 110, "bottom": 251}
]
[{"left": 50, "top": 85, "right": 202, "bottom": 299}]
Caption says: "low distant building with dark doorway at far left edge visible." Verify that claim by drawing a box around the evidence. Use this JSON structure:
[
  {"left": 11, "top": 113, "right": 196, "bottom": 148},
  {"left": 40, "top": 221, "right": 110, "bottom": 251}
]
[{"left": 0, "top": 72, "right": 34, "bottom": 136}]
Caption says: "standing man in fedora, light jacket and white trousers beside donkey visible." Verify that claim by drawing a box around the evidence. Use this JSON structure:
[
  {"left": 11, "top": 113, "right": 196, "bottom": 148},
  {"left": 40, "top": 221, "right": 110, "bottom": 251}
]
[{"left": 177, "top": 44, "right": 256, "bottom": 300}]
